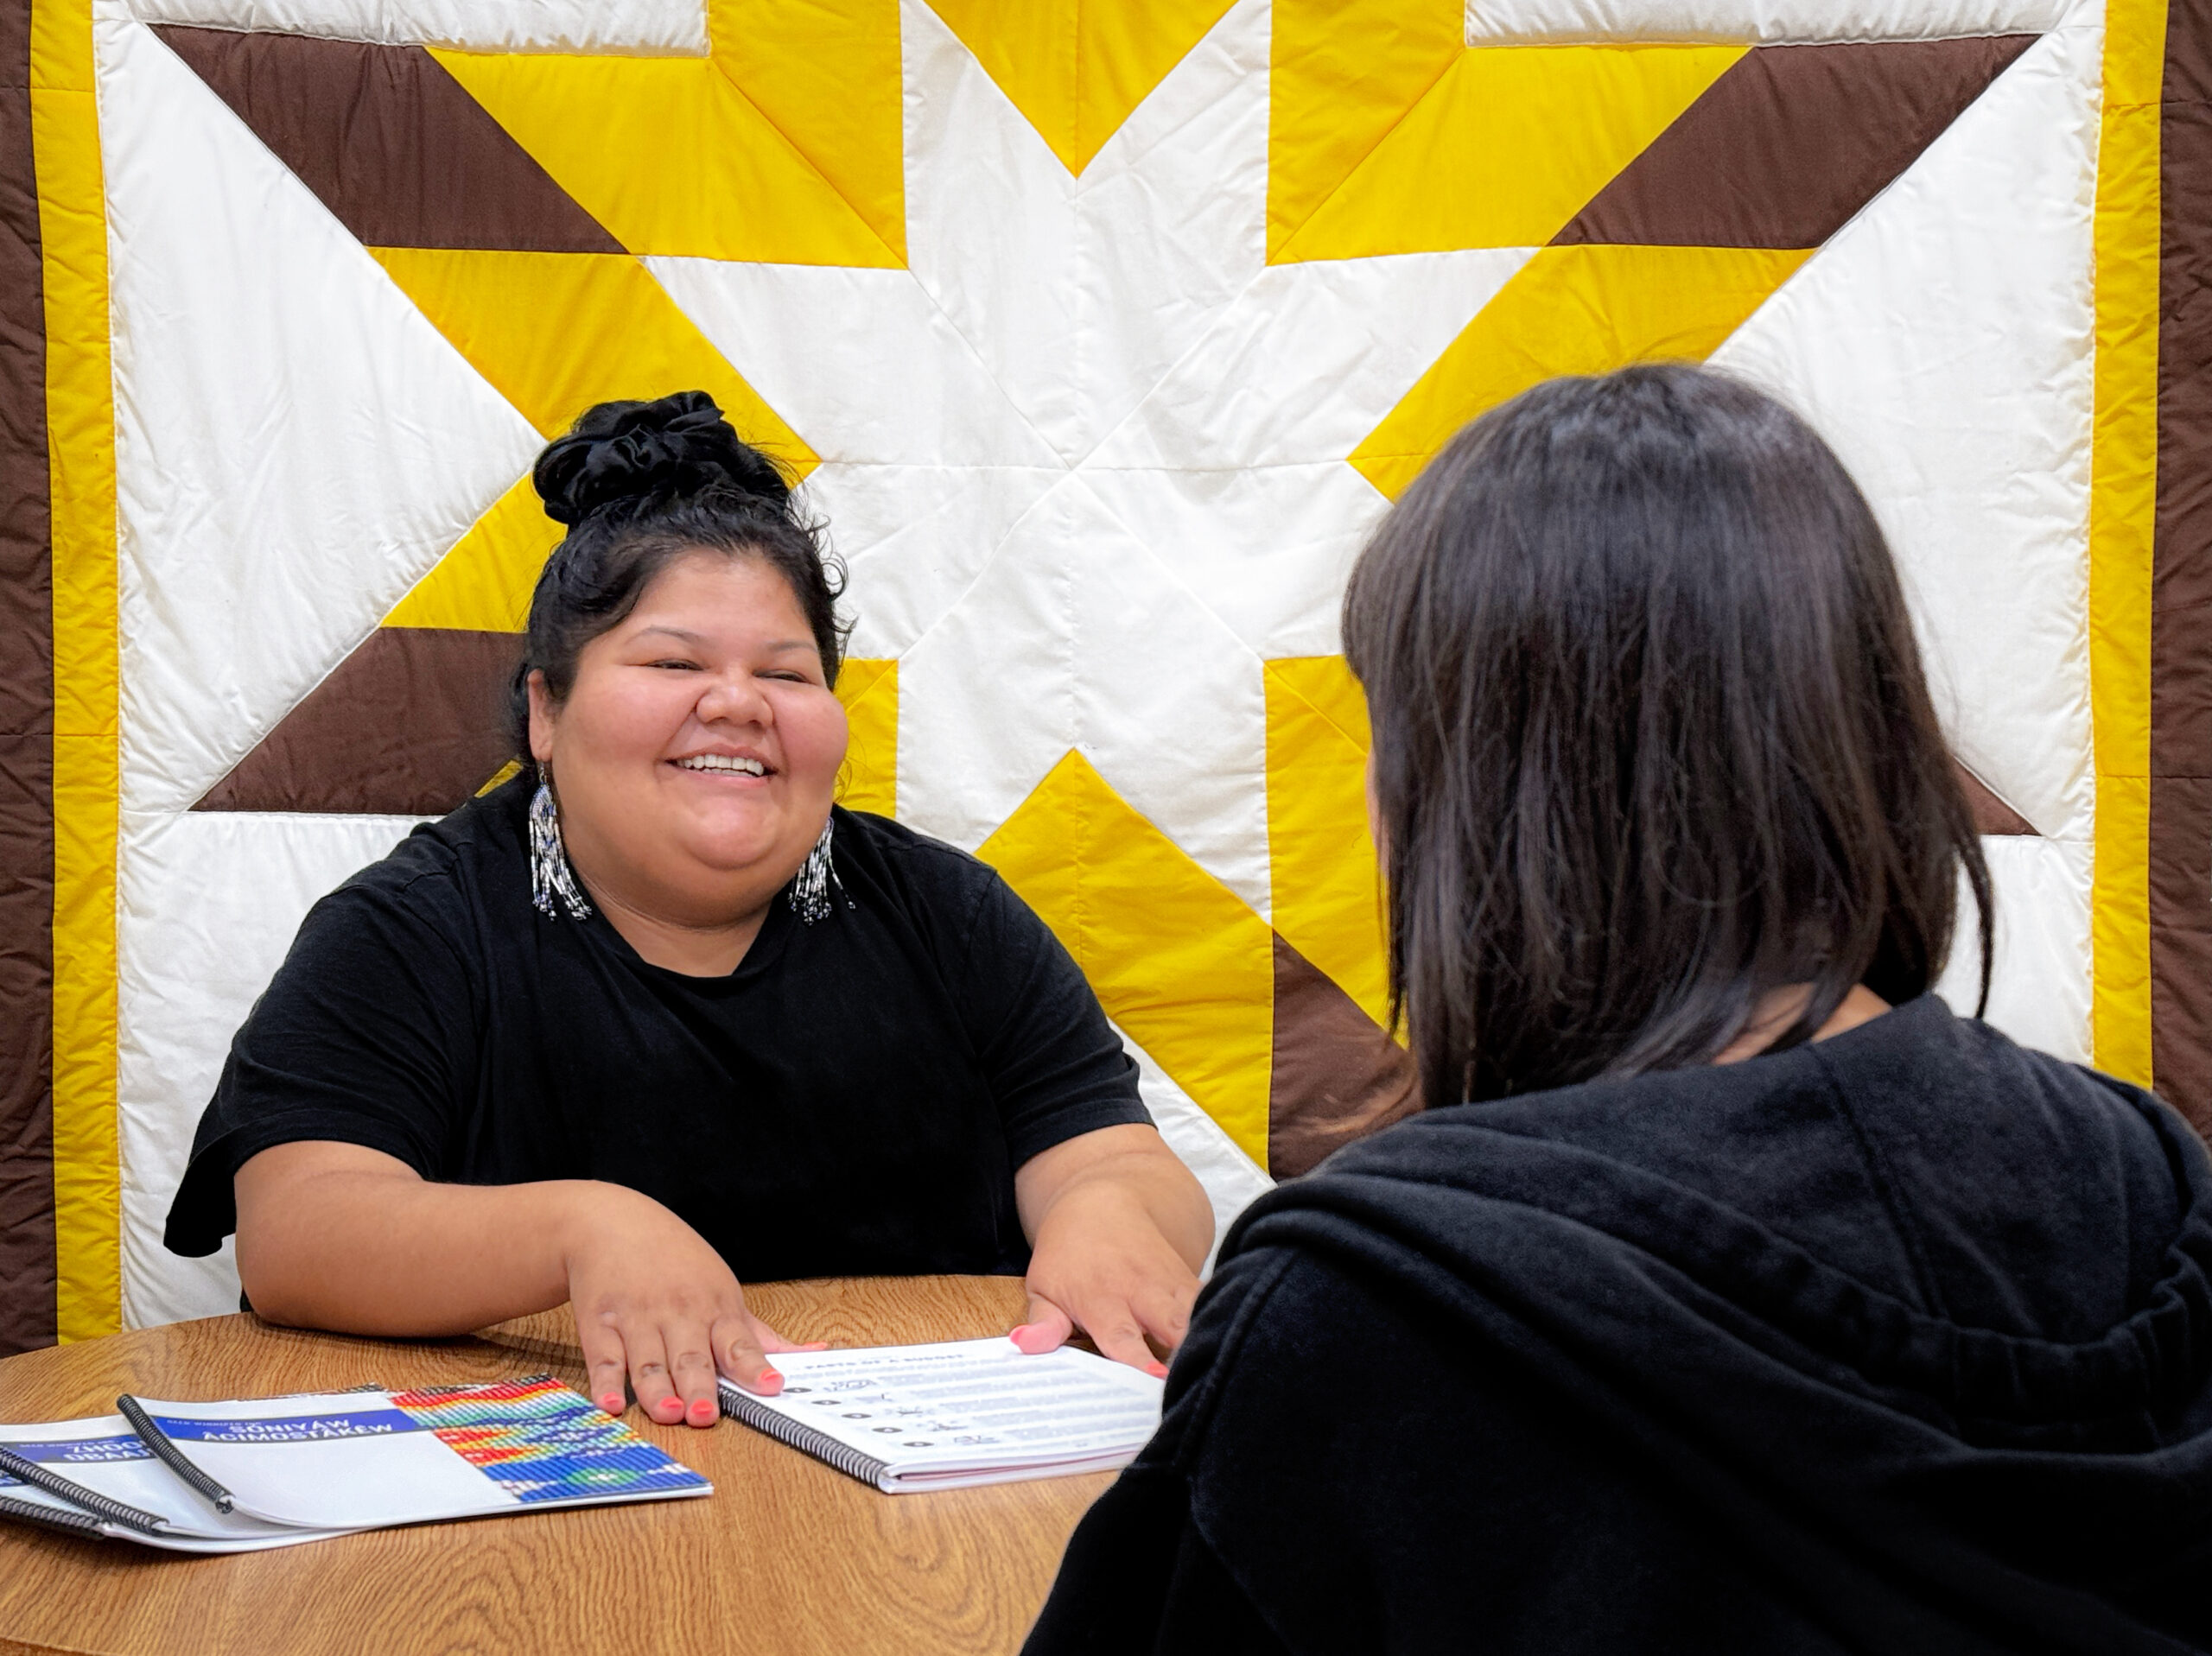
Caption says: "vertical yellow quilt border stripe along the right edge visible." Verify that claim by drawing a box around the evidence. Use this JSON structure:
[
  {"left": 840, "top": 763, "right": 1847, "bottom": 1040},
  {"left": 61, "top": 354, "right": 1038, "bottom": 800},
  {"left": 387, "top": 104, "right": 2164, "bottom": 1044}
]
[{"left": 2088, "top": 0, "right": 2165, "bottom": 1086}]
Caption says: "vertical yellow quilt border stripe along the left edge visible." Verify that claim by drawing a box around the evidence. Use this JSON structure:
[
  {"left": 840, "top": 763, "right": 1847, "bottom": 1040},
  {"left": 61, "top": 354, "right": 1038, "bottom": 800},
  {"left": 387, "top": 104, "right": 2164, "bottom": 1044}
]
[{"left": 31, "top": 0, "right": 122, "bottom": 1342}]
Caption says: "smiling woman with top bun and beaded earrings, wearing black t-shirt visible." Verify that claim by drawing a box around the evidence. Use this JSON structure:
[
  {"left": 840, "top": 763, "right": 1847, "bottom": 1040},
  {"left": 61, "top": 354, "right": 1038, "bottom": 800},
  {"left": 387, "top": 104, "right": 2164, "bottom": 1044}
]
[{"left": 168, "top": 391, "right": 1212, "bottom": 1426}]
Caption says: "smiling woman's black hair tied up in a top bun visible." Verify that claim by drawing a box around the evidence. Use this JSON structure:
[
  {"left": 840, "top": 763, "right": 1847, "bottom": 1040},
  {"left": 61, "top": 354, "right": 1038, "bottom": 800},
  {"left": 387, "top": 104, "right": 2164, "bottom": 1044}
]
[{"left": 509, "top": 391, "right": 852, "bottom": 760}]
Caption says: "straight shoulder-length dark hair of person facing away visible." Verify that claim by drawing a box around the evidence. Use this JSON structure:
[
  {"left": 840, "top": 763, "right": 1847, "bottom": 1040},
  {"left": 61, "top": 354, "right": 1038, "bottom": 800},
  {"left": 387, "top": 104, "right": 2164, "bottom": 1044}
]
[{"left": 1343, "top": 365, "right": 1991, "bottom": 1103}]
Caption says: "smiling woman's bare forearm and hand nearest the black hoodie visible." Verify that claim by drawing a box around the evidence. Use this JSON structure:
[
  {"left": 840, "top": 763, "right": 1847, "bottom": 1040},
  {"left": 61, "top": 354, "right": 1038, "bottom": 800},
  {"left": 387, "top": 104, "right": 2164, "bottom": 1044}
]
[{"left": 1013, "top": 1126, "right": 1214, "bottom": 1375}]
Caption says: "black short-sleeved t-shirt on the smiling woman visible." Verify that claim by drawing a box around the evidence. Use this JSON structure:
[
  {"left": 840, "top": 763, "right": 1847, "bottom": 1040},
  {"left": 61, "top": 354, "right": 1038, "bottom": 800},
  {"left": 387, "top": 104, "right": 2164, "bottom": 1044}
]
[{"left": 166, "top": 778, "right": 1150, "bottom": 1282}]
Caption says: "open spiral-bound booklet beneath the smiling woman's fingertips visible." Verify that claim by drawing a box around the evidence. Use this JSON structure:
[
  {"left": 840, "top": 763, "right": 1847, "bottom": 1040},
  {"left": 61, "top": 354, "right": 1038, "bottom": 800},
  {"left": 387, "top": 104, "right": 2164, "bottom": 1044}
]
[{"left": 721, "top": 1337, "right": 1161, "bottom": 1494}]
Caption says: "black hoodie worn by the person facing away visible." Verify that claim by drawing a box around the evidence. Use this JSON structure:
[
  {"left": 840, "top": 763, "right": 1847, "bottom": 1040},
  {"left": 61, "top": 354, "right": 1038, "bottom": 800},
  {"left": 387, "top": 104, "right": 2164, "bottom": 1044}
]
[{"left": 1028, "top": 997, "right": 2212, "bottom": 1656}]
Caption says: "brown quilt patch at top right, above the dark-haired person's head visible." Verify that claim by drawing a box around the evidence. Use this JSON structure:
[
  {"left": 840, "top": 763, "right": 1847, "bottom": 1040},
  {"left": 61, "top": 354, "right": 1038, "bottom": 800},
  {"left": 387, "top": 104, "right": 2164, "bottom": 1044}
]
[{"left": 1555, "top": 35, "right": 2035, "bottom": 248}]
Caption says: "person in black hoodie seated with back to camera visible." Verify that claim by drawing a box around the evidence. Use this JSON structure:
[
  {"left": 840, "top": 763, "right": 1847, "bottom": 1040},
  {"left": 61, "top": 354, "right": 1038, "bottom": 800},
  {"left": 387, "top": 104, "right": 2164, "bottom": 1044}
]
[{"left": 1028, "top": 367, "right": 2212, "bottom": 1656}]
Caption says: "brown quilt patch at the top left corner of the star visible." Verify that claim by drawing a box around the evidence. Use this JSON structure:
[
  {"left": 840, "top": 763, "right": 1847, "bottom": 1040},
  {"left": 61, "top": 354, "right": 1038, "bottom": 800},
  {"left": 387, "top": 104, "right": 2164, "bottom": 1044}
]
[{"left": 155, "top": 27, "right": 621, "bottom": 252}]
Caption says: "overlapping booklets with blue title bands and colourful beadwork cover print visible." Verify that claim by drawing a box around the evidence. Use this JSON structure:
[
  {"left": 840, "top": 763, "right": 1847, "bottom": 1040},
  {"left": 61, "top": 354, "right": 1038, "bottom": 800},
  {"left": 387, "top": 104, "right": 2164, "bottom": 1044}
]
[{"left": 0, "top": 1375, "right": 712, "bottom": 1552}]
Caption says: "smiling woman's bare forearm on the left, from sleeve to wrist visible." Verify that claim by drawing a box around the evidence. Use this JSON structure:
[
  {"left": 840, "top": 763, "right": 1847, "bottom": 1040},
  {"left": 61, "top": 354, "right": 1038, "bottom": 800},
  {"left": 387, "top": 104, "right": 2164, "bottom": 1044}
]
[{"left": 237, "top": 1143, "right": 606, "bottom": 1336}]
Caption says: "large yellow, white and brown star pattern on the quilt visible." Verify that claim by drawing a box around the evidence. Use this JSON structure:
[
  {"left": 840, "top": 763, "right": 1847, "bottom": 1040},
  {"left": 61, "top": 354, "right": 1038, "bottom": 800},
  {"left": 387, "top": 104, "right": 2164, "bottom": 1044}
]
[{"left": 121, "top": 0, "right": 2033, "bottom": 1264}]
